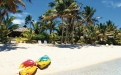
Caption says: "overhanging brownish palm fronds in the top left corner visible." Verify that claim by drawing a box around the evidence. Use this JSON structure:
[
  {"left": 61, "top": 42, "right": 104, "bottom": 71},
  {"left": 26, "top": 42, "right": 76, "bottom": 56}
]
[{"left": 0, "top": 0, "right": 31, "bottom": 23}]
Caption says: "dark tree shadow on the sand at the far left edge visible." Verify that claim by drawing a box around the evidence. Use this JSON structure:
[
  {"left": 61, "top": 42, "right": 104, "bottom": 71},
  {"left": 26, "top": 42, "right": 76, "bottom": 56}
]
[{"left": 0, "top": 43, "right": 26, "bottom": 52}]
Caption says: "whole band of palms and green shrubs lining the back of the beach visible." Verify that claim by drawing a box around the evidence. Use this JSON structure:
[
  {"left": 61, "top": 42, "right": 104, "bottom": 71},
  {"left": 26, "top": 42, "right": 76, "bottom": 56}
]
[{"left": 0, "top": 0, "right": 121, "bottom": 45}]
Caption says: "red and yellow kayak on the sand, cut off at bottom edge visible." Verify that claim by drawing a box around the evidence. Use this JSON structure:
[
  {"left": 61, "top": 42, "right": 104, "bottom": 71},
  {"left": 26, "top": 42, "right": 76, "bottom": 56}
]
[{"left": 19, "top": 59, "right": 37, "bottom": 75}]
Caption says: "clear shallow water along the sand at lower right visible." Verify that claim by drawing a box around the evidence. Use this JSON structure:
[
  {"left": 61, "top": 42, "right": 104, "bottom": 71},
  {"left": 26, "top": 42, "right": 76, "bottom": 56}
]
[{"left": 52, "top": 58, "right": 121, "bottom": 75}]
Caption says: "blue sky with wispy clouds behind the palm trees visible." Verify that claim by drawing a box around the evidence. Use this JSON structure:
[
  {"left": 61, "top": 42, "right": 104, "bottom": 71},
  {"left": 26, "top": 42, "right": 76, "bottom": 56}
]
[{"left": 10, "top": 0, "right": 121, "bottom": 28}]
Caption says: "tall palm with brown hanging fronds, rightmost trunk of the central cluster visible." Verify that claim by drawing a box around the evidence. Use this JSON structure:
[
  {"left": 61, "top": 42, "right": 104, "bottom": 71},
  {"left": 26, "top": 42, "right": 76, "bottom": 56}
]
[{"left": 67, "top": 2, "right": 82, "bottom": 44}]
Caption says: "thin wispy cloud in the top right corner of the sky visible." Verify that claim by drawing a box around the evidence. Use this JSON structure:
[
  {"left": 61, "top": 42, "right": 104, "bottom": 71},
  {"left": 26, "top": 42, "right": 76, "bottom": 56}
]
[{"left": 102, "top": 0, "right": 121, "bottom": 8}]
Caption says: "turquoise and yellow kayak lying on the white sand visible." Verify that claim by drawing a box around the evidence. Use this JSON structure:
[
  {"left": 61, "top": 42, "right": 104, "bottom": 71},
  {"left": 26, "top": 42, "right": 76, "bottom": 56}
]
[{"left": 36, "top": 55, "right": 51, "bottom": 69}]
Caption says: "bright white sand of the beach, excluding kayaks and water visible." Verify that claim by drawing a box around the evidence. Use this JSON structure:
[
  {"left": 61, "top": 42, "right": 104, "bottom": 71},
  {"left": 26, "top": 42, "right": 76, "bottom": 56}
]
[{"left": 0, "top": 44, "right": 121, "bottom": 75}]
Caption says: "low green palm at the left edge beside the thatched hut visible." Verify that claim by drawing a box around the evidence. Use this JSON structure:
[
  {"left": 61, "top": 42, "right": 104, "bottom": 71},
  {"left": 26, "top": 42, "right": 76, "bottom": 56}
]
[{"left": 0, "top": 16, "right": 19, "bottom": 42}]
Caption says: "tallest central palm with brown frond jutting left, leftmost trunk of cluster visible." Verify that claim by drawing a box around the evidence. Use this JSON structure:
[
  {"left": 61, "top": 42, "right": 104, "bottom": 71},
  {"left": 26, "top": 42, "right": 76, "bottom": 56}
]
[{"left": 43, "top": 0, "right": 81, "bottom": 43}]
